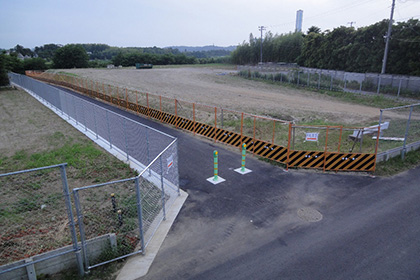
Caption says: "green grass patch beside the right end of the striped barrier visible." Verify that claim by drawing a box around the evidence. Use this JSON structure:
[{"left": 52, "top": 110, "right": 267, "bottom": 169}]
[{"left": 375, "top": 150, "right": 420, "bottom": 176}]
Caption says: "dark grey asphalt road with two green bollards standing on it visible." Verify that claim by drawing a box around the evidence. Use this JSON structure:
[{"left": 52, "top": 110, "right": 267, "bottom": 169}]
[{"left": 55, "top": 86, "right": 420, "bottom": 280}]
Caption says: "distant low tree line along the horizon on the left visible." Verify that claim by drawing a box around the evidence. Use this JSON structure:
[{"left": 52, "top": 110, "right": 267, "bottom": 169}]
[{"left": 1, "top": 44, "right": 230, "bottom": 73}]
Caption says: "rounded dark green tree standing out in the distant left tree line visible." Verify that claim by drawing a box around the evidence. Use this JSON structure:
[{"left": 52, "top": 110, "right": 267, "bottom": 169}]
[{"left": 53, "top": 44, "right": 89, "bottom": 68}]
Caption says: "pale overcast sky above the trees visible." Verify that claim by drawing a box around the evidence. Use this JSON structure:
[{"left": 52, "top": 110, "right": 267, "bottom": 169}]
[{"left": 0, "top": 0, "right": 420, "bottom": 49}]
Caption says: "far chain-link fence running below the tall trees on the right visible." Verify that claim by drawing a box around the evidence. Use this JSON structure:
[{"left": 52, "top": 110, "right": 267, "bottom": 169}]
[{"left": 238, "top": 65, "right": 420, "bottom": 98}]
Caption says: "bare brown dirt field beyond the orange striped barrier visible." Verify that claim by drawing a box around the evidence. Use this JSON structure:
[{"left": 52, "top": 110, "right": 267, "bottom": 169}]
[{"left": 60, "top": 67, "right": 386, "bottom": 126}]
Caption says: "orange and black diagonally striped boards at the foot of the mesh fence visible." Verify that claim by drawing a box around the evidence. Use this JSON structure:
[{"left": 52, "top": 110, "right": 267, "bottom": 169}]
[{"left": 28, "top": 73, "right": 376, "bottom": 172}]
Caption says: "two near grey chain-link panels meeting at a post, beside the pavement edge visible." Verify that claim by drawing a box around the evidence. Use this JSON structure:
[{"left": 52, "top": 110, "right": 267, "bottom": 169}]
[{"left": 73, "top": 138, "right": 179, "bottom": 270}]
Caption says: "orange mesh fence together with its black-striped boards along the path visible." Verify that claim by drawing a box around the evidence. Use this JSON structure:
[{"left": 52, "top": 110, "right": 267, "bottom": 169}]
[{"left": 26, "top": 71, "right": 380, "bottom": 172}]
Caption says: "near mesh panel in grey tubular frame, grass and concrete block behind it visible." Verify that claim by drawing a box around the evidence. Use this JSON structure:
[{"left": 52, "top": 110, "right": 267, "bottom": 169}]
[{"left": 73, "top": 178, "right": 144, "bottom": 269}]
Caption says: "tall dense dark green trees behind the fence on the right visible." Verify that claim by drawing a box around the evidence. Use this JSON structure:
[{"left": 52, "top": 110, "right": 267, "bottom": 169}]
[{"left": 231, "top": 19, "right": 420, "bottom": 76}]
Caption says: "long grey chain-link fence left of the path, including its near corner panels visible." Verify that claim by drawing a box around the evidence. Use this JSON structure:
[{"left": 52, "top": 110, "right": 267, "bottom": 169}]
[{"left": 2, "top": 73, "right": 179, "bottom": 276}]
